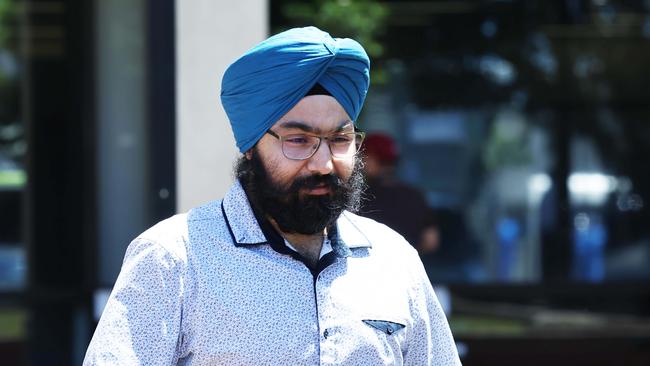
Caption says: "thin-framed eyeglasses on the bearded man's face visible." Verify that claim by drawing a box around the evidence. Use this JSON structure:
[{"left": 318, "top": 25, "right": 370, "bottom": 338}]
[{"left": 266, "top": 130, "right": 366, "bottom": 160}]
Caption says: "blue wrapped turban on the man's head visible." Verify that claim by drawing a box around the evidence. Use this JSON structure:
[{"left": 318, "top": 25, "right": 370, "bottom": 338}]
[{"left": 221, "top": 27, "right": 370, "bottom": 153}]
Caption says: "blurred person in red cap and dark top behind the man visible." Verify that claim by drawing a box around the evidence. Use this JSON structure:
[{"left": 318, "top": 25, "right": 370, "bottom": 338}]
[{"left": 360, "top": 132, "right": 440, "bottom": 255}]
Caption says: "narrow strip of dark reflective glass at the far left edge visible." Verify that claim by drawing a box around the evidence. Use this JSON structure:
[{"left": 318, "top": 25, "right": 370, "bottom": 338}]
[{"left": 0, "top": 0, "right": 27, "bottom": 363}]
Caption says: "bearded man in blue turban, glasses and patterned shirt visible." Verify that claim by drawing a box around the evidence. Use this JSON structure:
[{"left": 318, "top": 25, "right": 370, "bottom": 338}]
[{"left": 84, "top": 27, "right": 459, "bottom": 365}]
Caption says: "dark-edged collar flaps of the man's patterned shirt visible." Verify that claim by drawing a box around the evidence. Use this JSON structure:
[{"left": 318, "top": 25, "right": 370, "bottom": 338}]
[{"left": 221, "top": 180, "right": 372, "bottom": 256}]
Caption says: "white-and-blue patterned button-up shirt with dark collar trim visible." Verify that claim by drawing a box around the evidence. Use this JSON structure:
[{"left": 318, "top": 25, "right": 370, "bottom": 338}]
[{"left": 84, "top": 183, "right": 460, "bottom": 366}]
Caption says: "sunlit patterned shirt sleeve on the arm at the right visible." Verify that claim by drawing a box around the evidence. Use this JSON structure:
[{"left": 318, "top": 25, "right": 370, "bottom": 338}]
[{"left": 404, "top": 261, "right": 461, "bottom": 366}]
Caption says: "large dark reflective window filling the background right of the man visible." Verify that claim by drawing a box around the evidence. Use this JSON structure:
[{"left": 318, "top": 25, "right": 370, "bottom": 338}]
[{"left": 271, "top": 0, "right": 650, "bottom": 284}]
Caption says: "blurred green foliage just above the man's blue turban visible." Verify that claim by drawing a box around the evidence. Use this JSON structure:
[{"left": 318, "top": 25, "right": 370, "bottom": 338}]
[{"left": 282, "top": 0, "right": 388, "bottom": 58}]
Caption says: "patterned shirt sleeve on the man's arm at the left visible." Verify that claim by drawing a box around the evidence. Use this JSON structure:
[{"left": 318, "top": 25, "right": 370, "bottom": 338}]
[{"left": 83, "top": 239, "right": 185, "bottom": 365}]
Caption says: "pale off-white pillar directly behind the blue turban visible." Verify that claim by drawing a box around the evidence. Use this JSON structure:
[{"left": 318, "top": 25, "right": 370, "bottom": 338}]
[{"left": 176, "top": 0, "right": 268, "bottom": 212}]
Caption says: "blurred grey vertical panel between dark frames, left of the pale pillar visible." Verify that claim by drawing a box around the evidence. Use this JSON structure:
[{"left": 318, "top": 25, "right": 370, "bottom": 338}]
[{"left": 95, "top": 0, "right": 148, "bottom": 286}]
